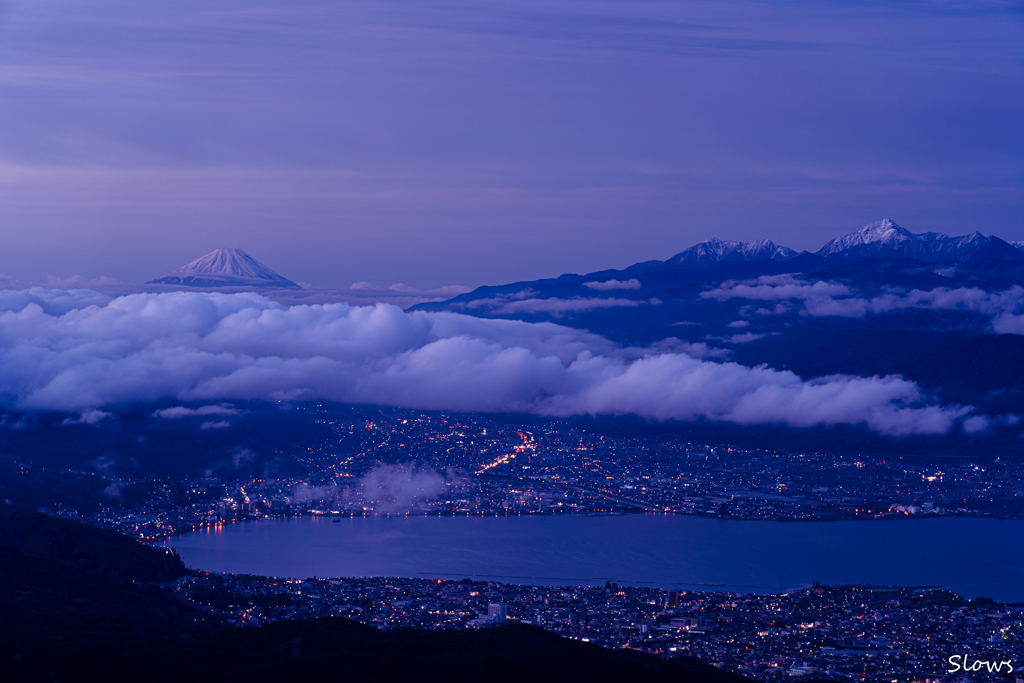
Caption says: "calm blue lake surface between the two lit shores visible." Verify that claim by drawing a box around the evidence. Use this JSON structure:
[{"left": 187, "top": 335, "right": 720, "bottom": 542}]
[{"left": 167, "top": 514, "right": 1024, "bottom": 600}]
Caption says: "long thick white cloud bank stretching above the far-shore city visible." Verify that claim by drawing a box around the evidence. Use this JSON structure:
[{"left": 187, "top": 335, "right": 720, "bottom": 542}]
[{"left": 0, "top": 291, "right": 972, "bottom": 435}]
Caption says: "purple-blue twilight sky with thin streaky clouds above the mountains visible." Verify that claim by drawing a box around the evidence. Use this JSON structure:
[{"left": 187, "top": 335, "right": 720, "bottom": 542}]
[{"left": 0, "top": 0, "right": 1024, "bottom": 288}]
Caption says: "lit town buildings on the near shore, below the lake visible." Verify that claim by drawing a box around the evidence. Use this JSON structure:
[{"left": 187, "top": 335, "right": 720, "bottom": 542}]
[{"left": 173, "top": 574, "right": 1024, "bottom": 682}]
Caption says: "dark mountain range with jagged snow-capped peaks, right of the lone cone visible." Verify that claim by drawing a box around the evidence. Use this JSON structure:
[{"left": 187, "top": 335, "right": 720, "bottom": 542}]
[{"left": 413, "top": 219, "right": 1024, "bottom": 413}]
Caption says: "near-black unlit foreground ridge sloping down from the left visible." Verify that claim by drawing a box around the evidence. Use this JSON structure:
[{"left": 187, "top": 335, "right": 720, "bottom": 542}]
[{"left": 0, "top": 511, "right": 746, "bottom": 683}]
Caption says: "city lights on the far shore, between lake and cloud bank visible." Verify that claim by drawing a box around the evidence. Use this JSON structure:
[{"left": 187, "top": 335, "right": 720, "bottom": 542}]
[{"left": 46, "top": 405, "right": 1024, "bottom": 539}]
